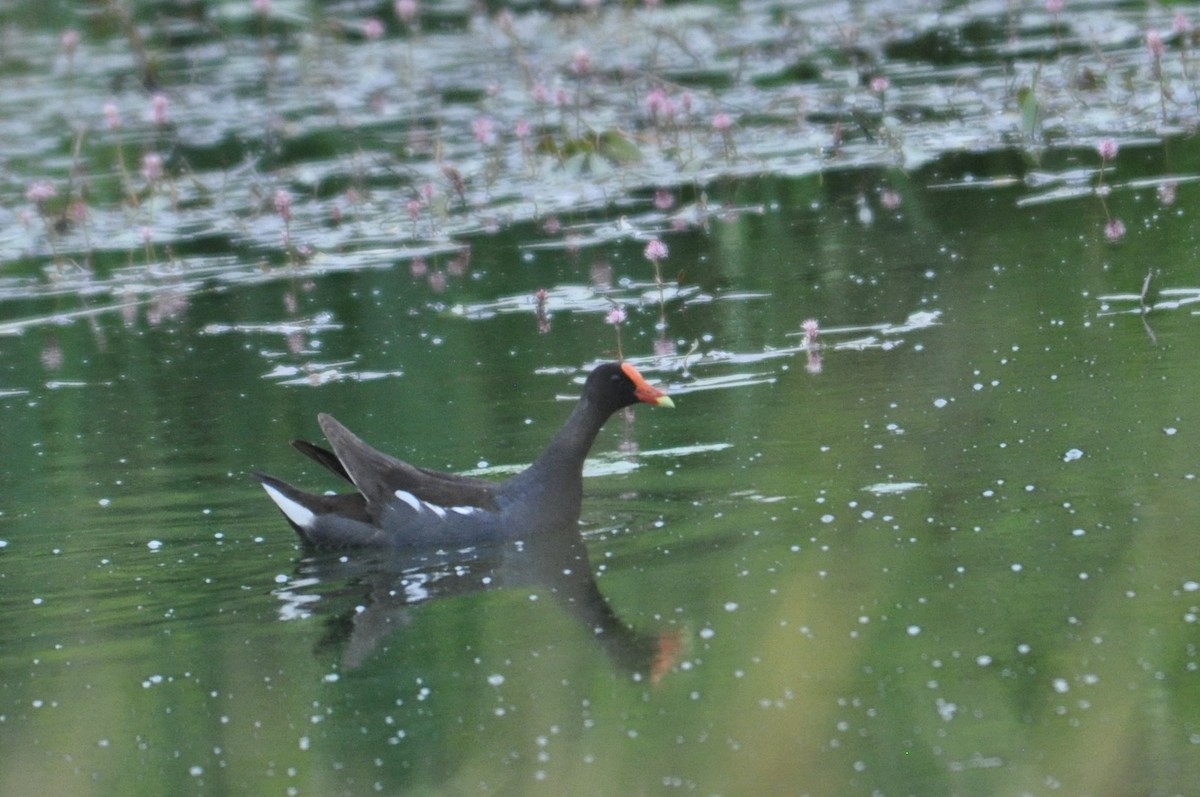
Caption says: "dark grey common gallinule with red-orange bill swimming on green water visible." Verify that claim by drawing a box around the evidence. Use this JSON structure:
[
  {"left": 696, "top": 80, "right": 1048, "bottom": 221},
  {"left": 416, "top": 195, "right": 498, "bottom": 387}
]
[{"left": 254, "top": 362, "right": 674, "bottom": 547}]
